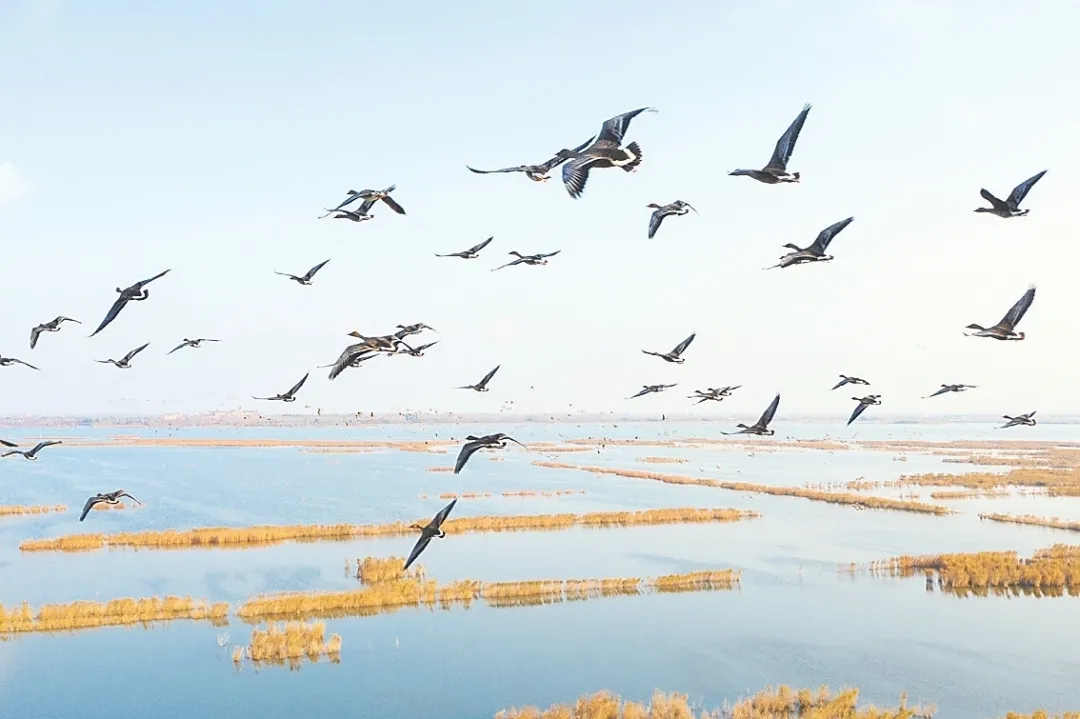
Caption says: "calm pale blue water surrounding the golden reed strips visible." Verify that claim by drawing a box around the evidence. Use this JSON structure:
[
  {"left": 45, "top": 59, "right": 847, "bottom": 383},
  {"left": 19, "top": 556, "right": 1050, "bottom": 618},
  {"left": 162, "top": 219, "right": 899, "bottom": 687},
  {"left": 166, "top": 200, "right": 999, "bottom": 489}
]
[{"left": 0, "top": 422, "right": 1080, "bottom": 719}]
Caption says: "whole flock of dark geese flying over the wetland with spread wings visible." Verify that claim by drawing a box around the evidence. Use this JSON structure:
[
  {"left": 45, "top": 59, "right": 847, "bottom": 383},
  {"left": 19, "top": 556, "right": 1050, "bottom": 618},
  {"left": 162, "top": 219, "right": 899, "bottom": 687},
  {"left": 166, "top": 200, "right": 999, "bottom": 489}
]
[{"left": 0, "top": 100, "right": 1047, "bottom": 569}]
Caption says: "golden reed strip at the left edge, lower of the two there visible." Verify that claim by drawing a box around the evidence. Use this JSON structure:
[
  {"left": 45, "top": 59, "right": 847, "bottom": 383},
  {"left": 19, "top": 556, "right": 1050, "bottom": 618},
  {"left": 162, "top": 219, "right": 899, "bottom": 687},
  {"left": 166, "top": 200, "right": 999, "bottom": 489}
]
[{"left": 0, "top": 596, "right": 229, "bottom": 633}]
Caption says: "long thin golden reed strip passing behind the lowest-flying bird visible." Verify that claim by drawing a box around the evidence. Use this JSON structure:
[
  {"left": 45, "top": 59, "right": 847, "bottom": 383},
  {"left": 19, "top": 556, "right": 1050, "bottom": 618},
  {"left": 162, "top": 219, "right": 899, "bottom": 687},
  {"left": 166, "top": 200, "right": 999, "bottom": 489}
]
[{"left": 18, "top": 507, "right": 760, "bottom": 552}]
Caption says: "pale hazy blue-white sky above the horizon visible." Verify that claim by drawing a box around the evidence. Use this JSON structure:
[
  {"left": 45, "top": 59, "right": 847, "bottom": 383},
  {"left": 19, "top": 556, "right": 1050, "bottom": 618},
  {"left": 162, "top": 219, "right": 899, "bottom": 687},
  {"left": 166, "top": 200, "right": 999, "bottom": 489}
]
[{"left": 0, "top": 0, "right": 1080, "bottom": 420}]
